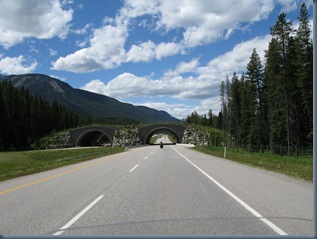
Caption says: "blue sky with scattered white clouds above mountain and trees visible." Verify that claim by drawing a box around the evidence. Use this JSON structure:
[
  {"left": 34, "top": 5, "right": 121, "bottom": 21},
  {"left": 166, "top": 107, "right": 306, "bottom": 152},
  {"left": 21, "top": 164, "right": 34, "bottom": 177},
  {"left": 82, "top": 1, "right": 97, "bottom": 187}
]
[{"left": 0, "top": 0, "right": 313, "bottom": 119}]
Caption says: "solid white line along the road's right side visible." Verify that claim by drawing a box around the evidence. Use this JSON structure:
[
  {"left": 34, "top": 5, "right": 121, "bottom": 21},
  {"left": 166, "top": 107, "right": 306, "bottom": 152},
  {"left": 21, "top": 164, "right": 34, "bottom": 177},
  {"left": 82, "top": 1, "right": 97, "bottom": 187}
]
[{"left": 171, "top": 146, "right": 287, "bottom": 235}]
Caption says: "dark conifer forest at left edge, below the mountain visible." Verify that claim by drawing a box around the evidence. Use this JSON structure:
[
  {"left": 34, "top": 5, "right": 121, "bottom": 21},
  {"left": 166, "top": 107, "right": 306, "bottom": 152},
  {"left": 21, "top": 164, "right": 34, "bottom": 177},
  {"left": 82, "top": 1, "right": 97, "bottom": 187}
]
[{"left": 0, "top": 81, "right": 80, "bottom": 151}]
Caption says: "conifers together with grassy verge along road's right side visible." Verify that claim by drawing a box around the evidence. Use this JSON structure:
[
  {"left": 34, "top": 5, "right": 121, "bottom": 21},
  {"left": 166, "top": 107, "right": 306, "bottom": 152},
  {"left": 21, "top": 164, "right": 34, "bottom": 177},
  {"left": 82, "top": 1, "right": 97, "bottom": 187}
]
[{"left": 185, "top": 3, "right": 313, "bottom": 181}]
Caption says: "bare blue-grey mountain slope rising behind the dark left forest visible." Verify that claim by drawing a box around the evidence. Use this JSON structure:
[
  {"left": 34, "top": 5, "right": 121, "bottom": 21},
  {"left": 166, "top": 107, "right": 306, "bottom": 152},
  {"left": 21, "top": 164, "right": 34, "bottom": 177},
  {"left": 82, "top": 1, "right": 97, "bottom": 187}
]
[{"left": 0, "top": 74, "right": 180, "bottom": 123}]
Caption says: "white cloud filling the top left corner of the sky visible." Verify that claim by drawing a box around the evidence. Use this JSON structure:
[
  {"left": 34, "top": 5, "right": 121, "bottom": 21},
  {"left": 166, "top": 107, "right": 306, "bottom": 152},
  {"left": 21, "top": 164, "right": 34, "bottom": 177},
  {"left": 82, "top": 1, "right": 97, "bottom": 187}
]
[{"left": 0, "top": 0, "right": 73, "bottom": 49}]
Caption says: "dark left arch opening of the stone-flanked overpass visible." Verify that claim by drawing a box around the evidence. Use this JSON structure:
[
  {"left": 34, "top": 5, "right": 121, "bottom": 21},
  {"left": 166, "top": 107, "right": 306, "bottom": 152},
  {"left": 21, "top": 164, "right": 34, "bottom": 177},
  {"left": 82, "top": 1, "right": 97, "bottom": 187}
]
[{"left": 76, "top": 130, "right": 112, "bottom": 147}]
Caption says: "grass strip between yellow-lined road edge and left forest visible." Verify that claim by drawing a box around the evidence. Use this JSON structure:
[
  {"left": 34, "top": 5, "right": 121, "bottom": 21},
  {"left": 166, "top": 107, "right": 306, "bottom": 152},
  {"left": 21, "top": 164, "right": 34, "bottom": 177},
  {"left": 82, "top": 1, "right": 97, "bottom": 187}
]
[{"left": 0, "top": 147, "right": 124, "bottom": 182}]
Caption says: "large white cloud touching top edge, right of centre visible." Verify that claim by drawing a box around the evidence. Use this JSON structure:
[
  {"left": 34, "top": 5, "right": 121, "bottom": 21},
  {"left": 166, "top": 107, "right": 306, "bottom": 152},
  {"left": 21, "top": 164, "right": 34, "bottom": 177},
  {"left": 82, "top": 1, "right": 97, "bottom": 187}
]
[{"left": 120, "top": 0, "right": 274, "bottom": 47}]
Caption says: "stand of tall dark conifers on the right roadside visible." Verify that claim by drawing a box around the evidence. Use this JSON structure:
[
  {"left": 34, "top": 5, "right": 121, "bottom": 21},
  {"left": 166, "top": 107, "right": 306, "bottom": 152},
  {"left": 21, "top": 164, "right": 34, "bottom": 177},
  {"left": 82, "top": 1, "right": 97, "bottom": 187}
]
[{"left": 218, "top": 3, "right": 313, "bottom": 156}]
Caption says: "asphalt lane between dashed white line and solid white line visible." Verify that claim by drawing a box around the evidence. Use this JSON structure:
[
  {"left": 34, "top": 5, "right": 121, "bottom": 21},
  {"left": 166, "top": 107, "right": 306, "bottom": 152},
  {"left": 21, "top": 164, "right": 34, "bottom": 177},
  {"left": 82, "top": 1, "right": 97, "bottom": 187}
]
[{"left": 55, "top": 146, "right": 277, "bottom": 236}]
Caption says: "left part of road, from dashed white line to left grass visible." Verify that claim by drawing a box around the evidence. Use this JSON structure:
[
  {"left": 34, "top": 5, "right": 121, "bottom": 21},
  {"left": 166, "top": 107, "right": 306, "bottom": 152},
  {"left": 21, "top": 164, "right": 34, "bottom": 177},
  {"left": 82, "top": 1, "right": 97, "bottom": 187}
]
[{"left": 0, "top": 147, "right": 151, "bottom": 235}]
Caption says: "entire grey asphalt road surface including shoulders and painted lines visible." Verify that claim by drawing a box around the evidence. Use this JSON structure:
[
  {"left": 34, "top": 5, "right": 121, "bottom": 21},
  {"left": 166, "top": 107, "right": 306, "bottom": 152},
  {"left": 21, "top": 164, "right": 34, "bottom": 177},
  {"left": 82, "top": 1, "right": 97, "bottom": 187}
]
[{"left": 0, "top": 145, "right": 315, "bottom": 237}]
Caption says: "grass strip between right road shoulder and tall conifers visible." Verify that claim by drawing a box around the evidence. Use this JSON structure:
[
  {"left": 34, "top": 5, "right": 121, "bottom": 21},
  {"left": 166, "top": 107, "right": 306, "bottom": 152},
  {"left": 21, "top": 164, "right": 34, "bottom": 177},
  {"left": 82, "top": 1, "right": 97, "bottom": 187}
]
[{"left": 194, "top": 146, "right": 313, "bottom": 182}]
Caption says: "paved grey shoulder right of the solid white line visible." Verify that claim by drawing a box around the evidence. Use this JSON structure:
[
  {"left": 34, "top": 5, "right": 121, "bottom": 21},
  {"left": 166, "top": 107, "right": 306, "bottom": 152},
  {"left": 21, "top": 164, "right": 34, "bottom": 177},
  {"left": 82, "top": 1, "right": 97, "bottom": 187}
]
[{"left": 172, "top": 146, "right": 315, "bottom": 235}]
